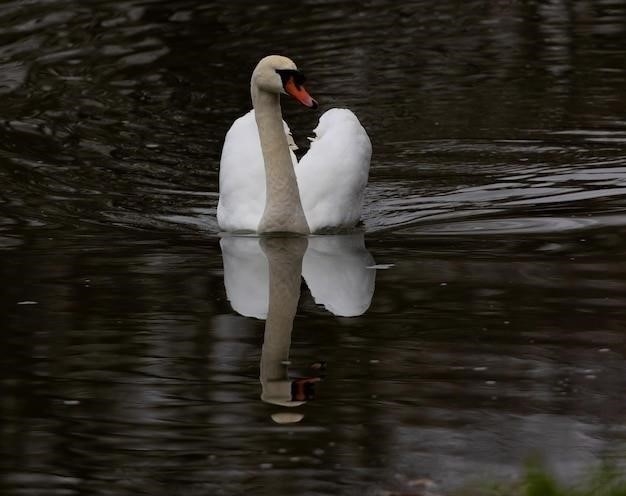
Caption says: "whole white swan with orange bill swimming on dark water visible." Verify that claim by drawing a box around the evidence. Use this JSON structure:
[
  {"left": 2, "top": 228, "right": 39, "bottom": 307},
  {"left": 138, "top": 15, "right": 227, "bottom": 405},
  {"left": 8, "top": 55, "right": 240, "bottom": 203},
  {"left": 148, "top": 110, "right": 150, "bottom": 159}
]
[{"left": 217, "top": 55, "right": 372, "bottom": 234}]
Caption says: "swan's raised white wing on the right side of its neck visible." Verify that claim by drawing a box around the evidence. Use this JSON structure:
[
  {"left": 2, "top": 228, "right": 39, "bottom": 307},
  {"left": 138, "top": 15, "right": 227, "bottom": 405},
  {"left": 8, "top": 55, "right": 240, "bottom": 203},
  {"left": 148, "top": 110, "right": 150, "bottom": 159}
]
[{"left": 296, "top": 109, "right": 372, "bottom": 232}]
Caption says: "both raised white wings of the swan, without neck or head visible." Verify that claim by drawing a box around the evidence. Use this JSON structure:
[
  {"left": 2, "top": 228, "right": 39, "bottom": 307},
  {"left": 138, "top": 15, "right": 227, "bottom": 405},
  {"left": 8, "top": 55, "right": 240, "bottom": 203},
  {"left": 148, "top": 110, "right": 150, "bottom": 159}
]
[{"left": 217, "top": 109, "right": 372, "bottom": 232}]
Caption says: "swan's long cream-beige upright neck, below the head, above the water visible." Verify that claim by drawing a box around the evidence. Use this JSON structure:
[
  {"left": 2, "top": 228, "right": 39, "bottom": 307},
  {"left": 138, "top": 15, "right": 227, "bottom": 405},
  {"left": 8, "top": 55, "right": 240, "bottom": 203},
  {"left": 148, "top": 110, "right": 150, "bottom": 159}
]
[{"left": 251, "top": 84, "right": 310, "bottom": 234}]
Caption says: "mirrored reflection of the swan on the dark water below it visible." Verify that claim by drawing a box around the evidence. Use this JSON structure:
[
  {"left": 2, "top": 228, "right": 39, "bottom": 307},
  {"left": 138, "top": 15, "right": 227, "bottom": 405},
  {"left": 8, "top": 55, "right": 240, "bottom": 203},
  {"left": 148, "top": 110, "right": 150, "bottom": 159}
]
[{"left": 220, "top": 233, "right": 376, "bottom": 423}]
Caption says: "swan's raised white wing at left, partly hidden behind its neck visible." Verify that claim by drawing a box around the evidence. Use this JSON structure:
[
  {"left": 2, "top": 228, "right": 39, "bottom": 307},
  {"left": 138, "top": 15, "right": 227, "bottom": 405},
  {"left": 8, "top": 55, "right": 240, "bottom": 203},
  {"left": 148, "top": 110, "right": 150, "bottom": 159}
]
[{"left": 217, "top": 110, "right": 297, "bottom": 231}]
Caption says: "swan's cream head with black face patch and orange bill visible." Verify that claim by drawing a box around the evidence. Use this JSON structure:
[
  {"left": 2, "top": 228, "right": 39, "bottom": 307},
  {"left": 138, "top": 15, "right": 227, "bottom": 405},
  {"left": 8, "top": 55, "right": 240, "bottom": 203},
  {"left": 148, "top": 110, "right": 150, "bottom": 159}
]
[{"left": 250, "top": 55, "right": 317, "bottom": 109}]
